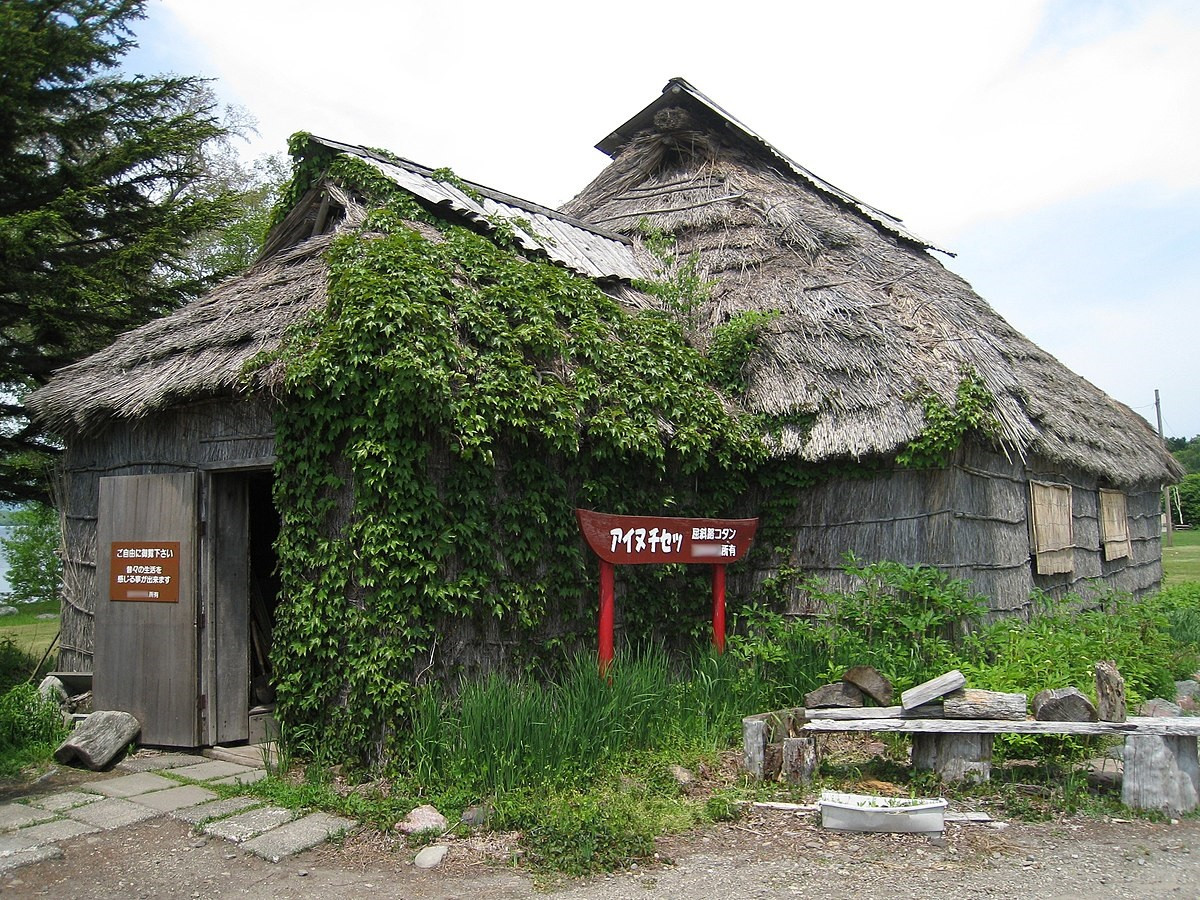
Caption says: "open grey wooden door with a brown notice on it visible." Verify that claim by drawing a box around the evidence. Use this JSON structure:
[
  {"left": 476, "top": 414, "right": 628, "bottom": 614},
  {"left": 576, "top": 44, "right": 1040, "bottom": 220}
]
[{"left": 92, "top": 473, "right": 200, "bottom": 746}]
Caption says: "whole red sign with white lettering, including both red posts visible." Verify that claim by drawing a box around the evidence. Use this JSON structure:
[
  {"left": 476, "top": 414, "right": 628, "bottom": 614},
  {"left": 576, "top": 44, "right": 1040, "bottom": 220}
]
[{"left": 575, "top": 509, "right": 758, "bottom": 672}]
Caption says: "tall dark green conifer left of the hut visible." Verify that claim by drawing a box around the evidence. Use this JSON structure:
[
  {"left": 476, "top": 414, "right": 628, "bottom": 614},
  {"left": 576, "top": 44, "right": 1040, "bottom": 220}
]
[{"left": 0, "top": 0, "right": 248, "bottom": 500}]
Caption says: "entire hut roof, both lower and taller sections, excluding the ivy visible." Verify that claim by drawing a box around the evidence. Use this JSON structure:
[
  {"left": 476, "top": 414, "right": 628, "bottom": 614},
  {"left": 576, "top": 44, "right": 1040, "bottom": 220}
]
[{"left": 28, "top": 79, "right": 1182, "bottom": 485}]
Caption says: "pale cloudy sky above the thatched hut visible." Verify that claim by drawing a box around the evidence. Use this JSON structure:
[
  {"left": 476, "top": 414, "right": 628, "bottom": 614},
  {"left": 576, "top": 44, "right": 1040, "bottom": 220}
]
[{"left": 127, "top": 0, "right": 1200, "bottom": 437}]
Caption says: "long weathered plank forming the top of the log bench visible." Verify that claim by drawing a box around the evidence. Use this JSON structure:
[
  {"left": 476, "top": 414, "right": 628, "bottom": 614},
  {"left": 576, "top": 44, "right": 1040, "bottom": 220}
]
[{"left": 800, "top": 716, "right": 1200, "bottom": 737}]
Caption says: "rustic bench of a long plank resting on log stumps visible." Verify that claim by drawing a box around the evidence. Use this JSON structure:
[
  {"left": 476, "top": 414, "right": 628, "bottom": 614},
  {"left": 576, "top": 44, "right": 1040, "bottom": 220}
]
[{"left": 742, "top": 707, "right": 1200, "bottom": 815}]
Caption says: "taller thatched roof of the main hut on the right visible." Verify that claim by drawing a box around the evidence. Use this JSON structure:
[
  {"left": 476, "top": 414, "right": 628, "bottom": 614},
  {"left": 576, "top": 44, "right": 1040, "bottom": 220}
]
[{"left": 564, "top": 79, "right": 1182, "bottom": 485}]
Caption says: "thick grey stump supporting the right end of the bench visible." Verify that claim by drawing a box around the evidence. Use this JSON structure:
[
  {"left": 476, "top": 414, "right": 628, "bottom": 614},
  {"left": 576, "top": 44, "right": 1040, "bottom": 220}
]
[{"left": 1121, "top": 734, "right": 1200, "bottom": 816}]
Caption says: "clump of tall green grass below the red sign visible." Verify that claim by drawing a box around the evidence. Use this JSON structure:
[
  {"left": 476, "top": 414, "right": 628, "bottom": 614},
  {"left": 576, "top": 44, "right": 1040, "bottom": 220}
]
[{"left": 403, "top": 647, "right": 748, "bottom": 793}]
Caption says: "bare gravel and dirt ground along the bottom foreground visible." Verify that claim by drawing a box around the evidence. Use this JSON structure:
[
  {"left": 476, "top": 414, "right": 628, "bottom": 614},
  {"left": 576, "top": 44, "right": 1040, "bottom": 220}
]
[{"left": 0, "top": 811, "right": 1200, "bottom": 900}]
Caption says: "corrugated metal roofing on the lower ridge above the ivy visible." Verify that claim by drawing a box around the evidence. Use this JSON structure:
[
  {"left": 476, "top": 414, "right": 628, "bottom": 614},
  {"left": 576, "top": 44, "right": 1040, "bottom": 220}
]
[{"left": 312, "top": 137, "right": 649, "bottom": 281}]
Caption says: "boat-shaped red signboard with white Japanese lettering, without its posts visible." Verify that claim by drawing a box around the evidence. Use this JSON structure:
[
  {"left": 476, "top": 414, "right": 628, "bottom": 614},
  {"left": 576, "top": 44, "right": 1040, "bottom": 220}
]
[{"left": 575, "top": 509, "right": 758, "bottom": 565}]
